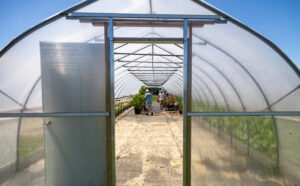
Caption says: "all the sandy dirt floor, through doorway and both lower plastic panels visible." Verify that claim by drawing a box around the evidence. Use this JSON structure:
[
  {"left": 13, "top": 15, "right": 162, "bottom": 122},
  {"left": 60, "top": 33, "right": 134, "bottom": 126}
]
[{"left": 3, "top": 102, "right": 294, "bottom": 186}]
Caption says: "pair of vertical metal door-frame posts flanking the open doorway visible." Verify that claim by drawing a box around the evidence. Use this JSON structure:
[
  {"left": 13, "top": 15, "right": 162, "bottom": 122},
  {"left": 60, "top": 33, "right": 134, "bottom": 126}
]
[{"left": 104, "top": 14, "right": 192, "bottom": 186}]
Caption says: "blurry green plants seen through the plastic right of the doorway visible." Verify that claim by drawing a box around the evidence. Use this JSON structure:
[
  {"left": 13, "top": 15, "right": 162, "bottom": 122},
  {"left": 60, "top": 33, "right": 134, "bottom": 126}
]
[{"left": 192, "top": 102, "right": 277, "bottom": 160}]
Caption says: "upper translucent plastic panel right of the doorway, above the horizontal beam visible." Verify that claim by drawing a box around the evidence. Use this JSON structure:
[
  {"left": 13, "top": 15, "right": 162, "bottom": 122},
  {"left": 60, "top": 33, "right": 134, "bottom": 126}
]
[{"left": 192, "top": 22, "right": 300, "bottom": 111}]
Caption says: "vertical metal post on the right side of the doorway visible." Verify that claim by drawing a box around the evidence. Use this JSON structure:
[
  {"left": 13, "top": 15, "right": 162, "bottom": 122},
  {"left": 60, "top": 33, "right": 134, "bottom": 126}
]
[{"left": 183, "top": 19, "right": 191, "bottom": 186}]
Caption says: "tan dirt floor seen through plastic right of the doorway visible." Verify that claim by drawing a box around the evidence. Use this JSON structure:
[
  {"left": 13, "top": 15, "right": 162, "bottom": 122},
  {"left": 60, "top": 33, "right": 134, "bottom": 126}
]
[{"left": 192, "top": 120, "right": 295, "bottom": 186}]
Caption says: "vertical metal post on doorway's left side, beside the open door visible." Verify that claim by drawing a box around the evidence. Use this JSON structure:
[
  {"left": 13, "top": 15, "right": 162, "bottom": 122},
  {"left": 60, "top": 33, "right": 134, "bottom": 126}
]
[{"left": 108, "top": 17, "right": 116, "bottom": 186}]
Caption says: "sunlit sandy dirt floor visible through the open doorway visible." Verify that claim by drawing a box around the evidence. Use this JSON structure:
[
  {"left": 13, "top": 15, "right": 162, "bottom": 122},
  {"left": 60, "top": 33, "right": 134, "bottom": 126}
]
[{"left": 115, "top": 102, "right": 183, "bottom": 185}]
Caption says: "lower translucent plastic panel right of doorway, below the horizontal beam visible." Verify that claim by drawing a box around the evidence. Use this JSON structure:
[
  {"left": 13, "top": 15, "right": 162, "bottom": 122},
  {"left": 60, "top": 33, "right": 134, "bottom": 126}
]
[{"left": 191, "top": 116, "right": 299, "bottom": 185}]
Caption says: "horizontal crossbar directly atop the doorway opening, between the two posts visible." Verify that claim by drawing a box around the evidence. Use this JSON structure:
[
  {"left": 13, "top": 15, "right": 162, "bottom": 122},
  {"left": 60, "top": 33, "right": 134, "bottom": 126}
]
[{"left": 114, "top": 37, "right": 183, "bottom": 44}]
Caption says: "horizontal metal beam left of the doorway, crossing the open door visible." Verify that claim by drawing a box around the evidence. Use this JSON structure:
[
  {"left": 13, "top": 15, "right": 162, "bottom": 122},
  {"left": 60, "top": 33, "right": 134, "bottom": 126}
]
[{"left": 0, "top": 112, "right": 109, "bottom": 118}]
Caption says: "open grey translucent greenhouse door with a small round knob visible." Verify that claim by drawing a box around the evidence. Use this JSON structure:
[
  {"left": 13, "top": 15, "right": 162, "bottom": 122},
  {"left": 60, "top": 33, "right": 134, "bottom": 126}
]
[{"left": 40, "top": 42, "right": 109, "bottom": 185}]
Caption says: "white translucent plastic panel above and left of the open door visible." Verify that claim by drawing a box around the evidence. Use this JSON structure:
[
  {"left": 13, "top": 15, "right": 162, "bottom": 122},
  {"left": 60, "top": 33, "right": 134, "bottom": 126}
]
[{"left": 0, "top": 18, "right": 103, "bottom": 112}]
